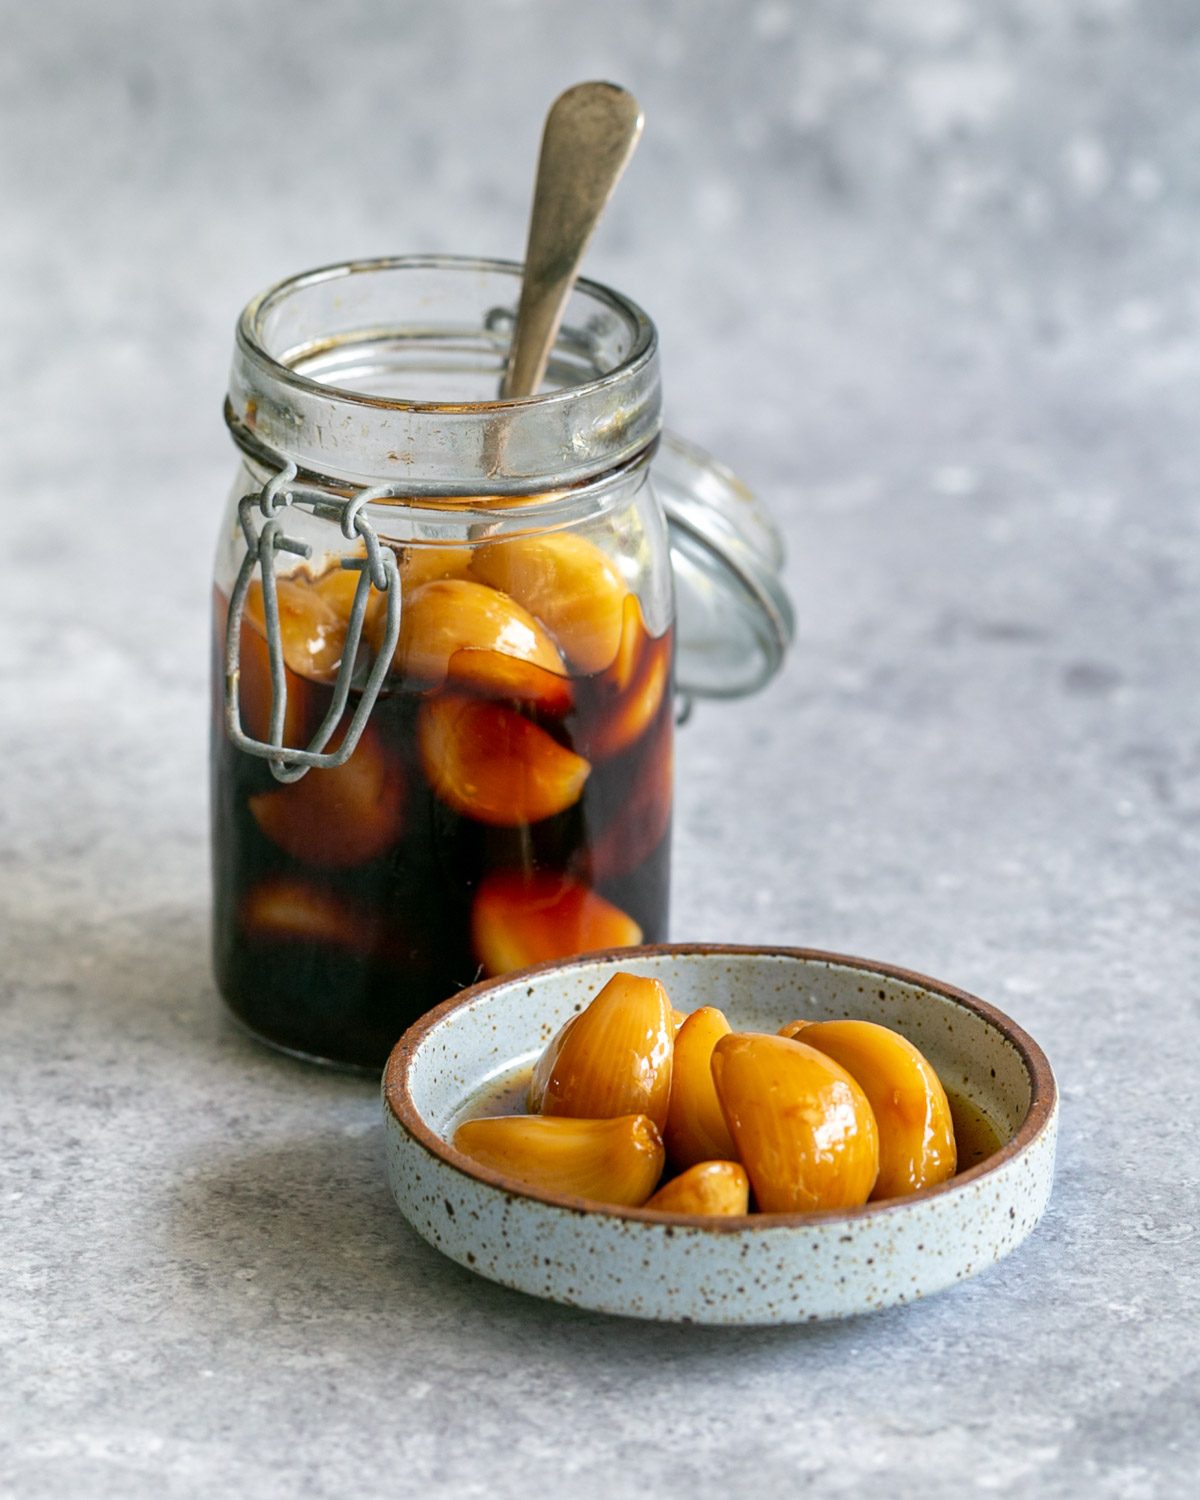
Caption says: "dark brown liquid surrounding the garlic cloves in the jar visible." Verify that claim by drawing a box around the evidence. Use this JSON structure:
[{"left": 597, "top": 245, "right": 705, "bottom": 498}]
[{"left": 212, "top": 579, "right": 672, "bottom": 1068}]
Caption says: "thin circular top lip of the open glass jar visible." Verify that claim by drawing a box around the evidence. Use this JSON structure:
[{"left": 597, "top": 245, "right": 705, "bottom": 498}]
[{"left": 236, "top": 255, "right": 659, "bottom": 414}]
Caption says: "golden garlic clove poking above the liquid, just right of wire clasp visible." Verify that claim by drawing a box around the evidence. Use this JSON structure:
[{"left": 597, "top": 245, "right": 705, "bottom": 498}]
[{"left": 393, "top": 578, "right": 566, "bottom": 690}]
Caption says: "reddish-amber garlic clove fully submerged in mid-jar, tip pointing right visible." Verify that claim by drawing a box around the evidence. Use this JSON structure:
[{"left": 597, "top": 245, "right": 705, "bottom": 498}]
[{"left": 417, "top": 693, "right": 591, "bottom": 828}]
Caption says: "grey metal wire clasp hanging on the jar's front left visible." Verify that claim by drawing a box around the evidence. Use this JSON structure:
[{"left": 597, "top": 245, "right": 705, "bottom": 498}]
[{"left": 225, "top": 464, "right": 401, "bottom": 782}]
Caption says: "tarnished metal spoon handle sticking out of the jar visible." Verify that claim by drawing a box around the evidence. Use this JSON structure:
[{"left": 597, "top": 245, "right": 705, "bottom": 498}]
[{"left": 500, "top": 83, "right": 642, "bottom": 399}]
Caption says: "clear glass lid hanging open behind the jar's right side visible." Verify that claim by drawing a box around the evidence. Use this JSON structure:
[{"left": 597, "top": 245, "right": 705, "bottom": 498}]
[{"left": 651, "top": 431, "right": 795, "bottom": 698}]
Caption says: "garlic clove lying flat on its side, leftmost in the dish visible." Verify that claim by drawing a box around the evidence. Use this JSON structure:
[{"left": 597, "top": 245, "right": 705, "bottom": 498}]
[{"left": 455, "top": 1115, "right": 663, "bottom": 1208}]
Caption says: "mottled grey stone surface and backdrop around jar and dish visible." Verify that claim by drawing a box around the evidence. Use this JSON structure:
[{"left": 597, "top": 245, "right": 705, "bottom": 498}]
[{"left": 0, "top": 0, "right": 1200, "bottom": 1500}]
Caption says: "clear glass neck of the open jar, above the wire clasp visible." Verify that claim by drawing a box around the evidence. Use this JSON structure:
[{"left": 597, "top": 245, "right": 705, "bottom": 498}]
[{"left": 227, "top": 255, "right": 662, "bottom": 495}]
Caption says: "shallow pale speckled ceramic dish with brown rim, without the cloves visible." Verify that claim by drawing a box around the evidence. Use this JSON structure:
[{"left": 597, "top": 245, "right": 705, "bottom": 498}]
[{"left": 384, "top": 945, "right": 1058, "bottom": 1323}]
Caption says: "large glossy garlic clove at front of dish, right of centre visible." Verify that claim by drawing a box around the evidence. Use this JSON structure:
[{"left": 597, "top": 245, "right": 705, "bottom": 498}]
[{"left": 713, "top": 1032, "right": 879, "bottom": 1214}]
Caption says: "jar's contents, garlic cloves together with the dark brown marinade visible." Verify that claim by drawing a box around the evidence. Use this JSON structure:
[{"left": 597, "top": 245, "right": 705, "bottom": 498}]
[{"left": 212, "top": 537, "right": 674, "bottom": 1067}]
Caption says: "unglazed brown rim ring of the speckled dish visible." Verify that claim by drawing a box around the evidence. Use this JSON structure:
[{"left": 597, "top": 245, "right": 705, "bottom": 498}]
[{"left": 383, "top": 942, "right": 1058, "bottom": 1235}]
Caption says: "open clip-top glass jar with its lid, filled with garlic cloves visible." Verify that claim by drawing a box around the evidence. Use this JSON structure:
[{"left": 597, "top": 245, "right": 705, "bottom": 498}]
[{"left": 212, "top": 258, "right": 791, "bottom": 1068}]
